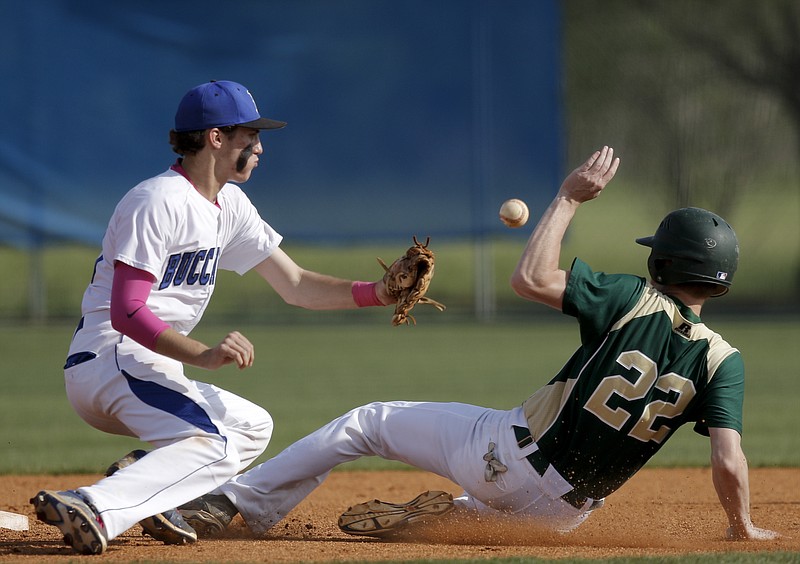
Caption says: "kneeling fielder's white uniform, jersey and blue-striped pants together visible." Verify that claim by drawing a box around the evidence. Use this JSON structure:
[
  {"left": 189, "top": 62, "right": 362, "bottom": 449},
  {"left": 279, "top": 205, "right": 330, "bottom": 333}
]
[{"left": 64, "top": 167, "right": 281, "bottom": 538}]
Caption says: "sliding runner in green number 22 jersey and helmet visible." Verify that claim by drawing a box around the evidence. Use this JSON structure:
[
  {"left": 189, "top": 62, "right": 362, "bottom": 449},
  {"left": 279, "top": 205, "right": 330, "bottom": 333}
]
[{"left": 172, "top": 147, "right": 778, "bottom": 539}]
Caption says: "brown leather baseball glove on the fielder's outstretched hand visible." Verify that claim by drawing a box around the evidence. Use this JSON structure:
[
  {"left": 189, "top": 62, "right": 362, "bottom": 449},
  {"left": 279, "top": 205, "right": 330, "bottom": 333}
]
[{"left": 378, "top": 236, "right": 445, "bottom": 325}]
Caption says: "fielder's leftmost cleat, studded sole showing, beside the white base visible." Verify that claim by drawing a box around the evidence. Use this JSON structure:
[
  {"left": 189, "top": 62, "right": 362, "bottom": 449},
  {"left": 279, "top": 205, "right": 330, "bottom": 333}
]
[{"left": 31, "top": 490, "right": 108, "bottom": 554}]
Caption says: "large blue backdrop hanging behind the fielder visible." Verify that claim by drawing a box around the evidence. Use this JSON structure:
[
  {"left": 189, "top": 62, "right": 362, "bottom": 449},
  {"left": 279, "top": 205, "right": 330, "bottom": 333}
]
[{"left": 0, "top": 0, "right": 564, "bottom": 247}]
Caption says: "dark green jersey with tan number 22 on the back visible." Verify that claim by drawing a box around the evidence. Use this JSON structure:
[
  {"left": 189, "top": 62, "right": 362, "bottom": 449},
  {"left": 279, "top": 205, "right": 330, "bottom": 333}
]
[{"left": 523, "top": 259, "right": 744, "bottom": 499}]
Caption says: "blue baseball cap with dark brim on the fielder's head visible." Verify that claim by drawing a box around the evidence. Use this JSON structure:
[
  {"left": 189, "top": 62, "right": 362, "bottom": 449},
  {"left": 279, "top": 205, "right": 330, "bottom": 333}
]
[{"left": 175, "top": 80, "right": 286, "bottom": 132}]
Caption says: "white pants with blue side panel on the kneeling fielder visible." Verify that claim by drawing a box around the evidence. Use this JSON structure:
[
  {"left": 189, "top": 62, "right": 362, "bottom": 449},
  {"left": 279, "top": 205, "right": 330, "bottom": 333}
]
[{"left": 64, "top": 334, "right": 273, "bottom": 539}]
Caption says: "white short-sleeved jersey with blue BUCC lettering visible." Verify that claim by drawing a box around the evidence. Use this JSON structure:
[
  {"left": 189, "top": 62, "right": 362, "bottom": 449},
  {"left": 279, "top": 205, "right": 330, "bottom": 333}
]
[{"left": 76, "top": 163, "right": 282, "bottom": 340}]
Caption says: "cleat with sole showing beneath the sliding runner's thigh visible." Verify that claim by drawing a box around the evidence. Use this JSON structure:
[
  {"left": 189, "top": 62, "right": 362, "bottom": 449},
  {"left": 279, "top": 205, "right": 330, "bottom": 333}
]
[{"left": 338, "top": 491, "right": 455, "bottom": 537}]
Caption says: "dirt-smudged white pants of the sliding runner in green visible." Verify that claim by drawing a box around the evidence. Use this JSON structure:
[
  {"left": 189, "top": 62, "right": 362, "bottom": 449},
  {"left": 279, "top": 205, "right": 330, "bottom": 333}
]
[{"left": 219, "top": 401, "right": 589, "bottom": 534}]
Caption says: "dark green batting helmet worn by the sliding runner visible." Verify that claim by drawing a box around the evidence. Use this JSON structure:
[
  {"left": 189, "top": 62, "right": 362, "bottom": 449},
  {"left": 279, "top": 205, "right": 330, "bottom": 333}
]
[{"left": 636, "top": 208, "right": 739, "bottom": 296}]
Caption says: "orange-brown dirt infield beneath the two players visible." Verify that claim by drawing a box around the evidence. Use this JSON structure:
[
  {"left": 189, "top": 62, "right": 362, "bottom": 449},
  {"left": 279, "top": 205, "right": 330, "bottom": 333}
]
[{"left": 0, "top": 468, "right": 800, "bottom": 562}]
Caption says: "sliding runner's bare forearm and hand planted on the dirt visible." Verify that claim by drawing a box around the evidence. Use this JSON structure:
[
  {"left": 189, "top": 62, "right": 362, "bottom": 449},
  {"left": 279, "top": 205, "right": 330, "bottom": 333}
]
[{"left": 709, "top": 428, "right": 780, "bottom": 540}]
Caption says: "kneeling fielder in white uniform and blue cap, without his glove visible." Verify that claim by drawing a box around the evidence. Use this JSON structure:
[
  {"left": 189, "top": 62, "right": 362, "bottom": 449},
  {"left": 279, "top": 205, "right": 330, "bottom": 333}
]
[{"left": 31, "top": 81, "right": 394, "bottom": 554}]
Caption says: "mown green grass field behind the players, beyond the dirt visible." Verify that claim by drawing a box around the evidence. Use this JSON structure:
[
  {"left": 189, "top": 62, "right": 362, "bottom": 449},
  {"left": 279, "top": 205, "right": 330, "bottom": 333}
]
[{"left": 0, "top": 320, "right": 800, "bottom": 473}]
